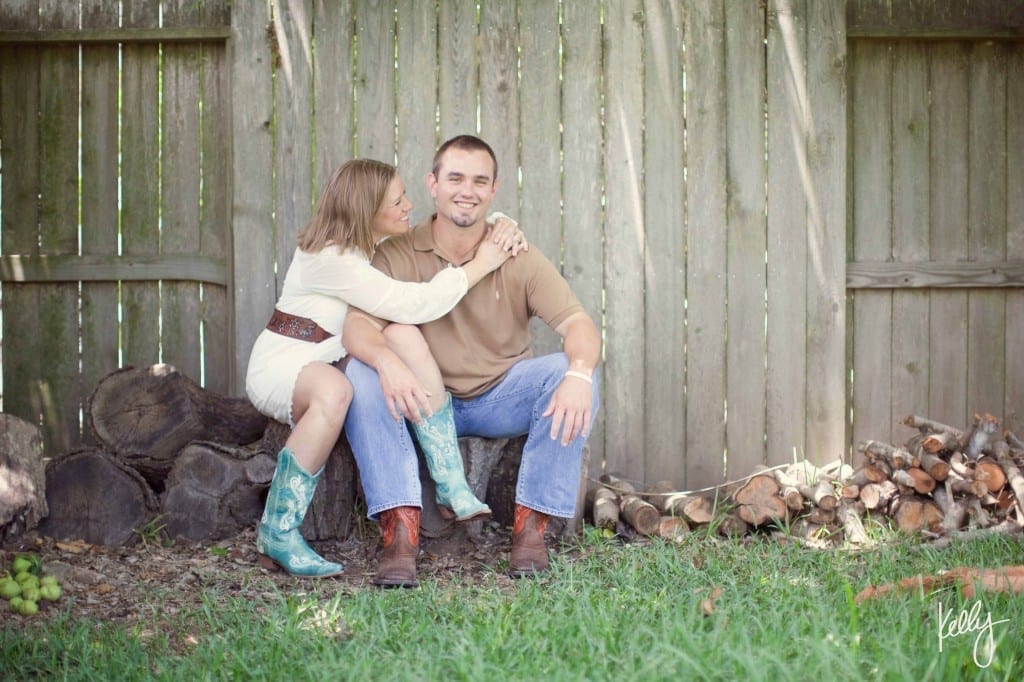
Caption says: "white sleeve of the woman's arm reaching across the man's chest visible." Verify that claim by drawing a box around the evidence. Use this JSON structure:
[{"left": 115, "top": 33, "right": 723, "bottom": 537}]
[{"left": 301, "top": 248, "right": 469, "bottom": 325}]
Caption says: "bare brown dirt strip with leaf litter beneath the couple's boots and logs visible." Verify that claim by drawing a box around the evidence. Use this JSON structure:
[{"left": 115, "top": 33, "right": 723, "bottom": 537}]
[{"left": 0, "top": 523, "right": 536, "bottom": 625}]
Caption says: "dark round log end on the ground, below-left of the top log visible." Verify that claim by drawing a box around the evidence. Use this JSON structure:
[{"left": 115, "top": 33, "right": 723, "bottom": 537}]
[{"left": 39, "top": 449, "right": 160, "bottom": 547}]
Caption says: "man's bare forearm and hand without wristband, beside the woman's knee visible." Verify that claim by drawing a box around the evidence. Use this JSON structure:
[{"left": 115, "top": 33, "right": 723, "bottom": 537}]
[{"left": 341, "top": 308, "right": 430, "bottom": 422}]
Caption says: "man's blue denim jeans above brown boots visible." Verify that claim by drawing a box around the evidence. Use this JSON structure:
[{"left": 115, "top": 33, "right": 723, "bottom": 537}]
[{"left": 345, "top": 353, "right": 600, "bottom": 519}]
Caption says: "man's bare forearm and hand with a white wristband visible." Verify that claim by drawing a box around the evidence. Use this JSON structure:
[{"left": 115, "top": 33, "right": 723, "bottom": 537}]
[{"left": 544, "top": 312, "right": 601, "bottom": 445}]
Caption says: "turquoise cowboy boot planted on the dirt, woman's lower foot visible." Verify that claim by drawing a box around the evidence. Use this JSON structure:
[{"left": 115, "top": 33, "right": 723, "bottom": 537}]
[{"left": 256, "top": 447, "right": 344, "bottom": 578}]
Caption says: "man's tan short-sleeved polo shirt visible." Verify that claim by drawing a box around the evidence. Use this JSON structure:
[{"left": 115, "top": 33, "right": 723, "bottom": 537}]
[{"left": 373, "top": 218, "right": 584, "bottom": 398}]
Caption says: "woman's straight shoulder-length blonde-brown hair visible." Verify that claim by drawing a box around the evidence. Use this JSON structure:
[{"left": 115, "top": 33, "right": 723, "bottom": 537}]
[{"left": 298, "top": 159, "right": 396, "bottom": 258}]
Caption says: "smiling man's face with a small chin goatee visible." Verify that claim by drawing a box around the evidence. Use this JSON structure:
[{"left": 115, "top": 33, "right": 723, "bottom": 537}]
[{"left": 427, "top": 148, "right": 498, "bottom": 227}]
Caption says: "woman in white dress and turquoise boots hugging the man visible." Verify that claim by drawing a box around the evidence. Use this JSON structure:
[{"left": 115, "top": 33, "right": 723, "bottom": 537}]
[{"left": 246, "top": 159, "right": 525, "bottom": 578}]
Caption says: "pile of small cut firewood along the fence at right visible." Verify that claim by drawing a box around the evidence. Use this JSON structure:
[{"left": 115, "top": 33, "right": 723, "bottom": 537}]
[{"left": 586, "top": 415, "right": 1024, "bottom": 545}]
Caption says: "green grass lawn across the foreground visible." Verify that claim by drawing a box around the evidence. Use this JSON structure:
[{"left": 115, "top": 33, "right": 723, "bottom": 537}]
[{"left": 0, "top": 528, "right": 1024, "bottom": 682}]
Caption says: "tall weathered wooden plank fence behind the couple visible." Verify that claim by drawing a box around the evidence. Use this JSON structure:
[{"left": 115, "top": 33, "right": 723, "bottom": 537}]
[{"left": 0, "top": 0, "right": 1024, "bottom": 487}]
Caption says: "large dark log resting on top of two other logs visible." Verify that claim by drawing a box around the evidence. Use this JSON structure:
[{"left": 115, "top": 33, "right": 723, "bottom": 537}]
[{"left": 88, "top": 365, "right": 267, "bottom": 483}]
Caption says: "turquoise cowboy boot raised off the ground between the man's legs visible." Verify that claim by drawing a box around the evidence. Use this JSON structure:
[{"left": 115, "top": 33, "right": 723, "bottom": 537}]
[{"left": 413, "top": 393, "right": 490, "bottom": 521}]
